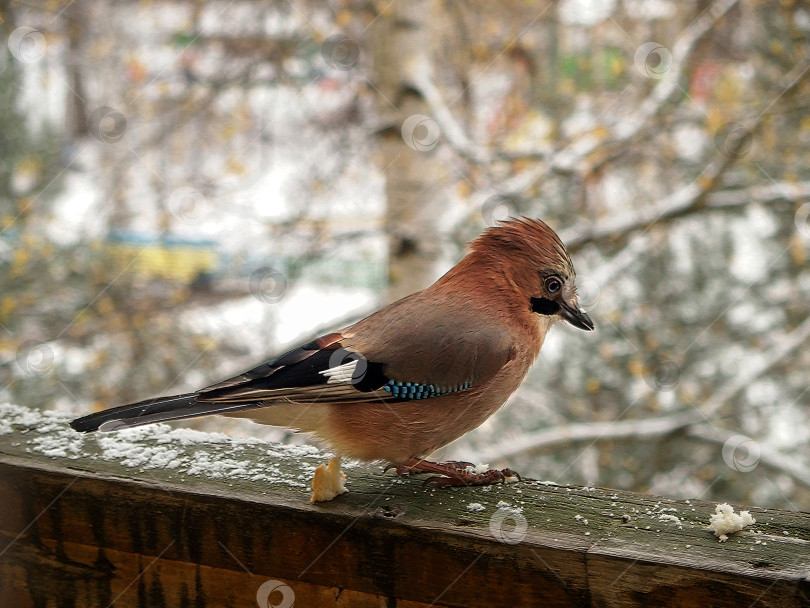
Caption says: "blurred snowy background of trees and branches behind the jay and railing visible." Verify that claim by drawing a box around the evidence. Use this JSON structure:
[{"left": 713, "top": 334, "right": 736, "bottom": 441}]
[{"left": 0, "top": 0, "right": 810, "bottom": 510}]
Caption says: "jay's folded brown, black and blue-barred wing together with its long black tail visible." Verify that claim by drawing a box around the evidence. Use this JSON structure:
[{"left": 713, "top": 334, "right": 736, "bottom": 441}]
[{"left": 72, "top": 305, "right": 515, "bottom": 431}]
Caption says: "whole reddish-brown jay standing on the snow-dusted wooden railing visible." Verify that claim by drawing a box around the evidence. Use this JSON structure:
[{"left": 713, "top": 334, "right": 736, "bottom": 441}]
[{"left": 70, "top": 217, "right": 594, "bottom": 501}]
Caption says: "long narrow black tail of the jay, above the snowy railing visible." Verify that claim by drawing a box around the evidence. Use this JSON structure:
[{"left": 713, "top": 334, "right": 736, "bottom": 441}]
[{"left": 70, "top": 393, "right": 256, "bottom": 433}]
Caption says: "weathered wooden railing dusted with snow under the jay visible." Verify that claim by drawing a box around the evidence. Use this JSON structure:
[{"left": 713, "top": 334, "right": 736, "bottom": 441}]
[{"left": 0, "top": 406, "right": 810, "bottom": 608}]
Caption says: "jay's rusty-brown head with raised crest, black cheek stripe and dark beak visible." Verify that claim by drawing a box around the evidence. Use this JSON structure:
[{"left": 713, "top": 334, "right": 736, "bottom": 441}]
[{"left": 472, "top": 218, "right": 594, "bottom": 331}]
